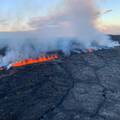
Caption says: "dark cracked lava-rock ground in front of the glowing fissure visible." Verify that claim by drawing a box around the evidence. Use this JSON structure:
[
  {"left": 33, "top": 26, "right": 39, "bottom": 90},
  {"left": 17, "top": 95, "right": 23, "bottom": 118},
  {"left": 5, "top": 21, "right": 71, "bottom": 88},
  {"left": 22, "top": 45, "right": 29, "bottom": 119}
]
[{"left": 0, "top": 35, "right": 120, "bottom": 120}]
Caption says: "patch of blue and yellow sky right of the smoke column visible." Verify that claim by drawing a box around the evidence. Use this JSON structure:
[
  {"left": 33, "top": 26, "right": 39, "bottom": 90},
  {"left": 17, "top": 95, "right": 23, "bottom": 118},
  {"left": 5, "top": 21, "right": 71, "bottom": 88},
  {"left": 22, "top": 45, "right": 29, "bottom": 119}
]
[{"left": 99, "top": 0, "right": 120, "bottom": 34}]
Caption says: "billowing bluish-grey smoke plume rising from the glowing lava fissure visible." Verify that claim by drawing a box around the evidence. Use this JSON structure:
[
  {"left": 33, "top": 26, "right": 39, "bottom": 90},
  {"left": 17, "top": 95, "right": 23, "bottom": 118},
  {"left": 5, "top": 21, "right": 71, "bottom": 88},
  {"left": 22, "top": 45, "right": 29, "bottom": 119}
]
[{"left": 0, "top": 0, "right": 119, "bottom": 65}]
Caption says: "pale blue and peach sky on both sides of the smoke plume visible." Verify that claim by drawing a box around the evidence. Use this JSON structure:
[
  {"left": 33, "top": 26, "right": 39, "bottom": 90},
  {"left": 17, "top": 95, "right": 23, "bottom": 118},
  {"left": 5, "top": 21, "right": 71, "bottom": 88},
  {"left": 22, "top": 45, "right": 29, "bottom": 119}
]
[{"left": 0, "top": 0, "right": 120, "bottom": 34}]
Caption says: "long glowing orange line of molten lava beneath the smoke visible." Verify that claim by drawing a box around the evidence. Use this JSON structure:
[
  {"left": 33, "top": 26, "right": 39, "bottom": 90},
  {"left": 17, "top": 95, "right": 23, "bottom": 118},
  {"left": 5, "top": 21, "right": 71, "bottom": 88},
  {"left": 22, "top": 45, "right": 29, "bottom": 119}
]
[{"left": 12, "top": 54, "right": 59, "bottom": 67}]
